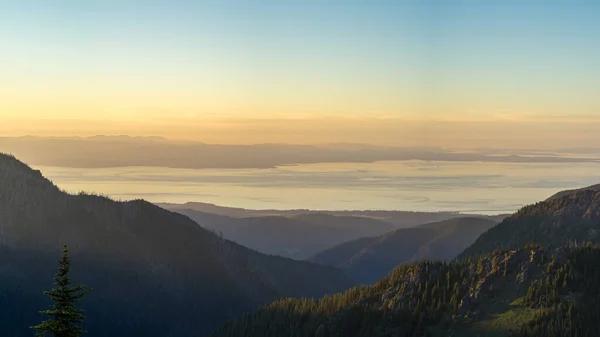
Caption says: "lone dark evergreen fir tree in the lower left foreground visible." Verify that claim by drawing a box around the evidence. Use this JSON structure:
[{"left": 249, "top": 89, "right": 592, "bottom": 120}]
[{"left": 31, "top": 245, "right": 91, "bottom": 337}]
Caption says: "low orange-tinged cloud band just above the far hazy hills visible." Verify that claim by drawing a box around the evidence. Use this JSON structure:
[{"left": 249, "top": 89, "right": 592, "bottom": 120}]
[{"left": 0, "top": 113, "right": 600, "bottom": 150}]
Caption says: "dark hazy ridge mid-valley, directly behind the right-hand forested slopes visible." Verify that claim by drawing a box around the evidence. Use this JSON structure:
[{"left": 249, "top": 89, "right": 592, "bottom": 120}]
[{"left": 309, "top": 217, "right": 497, "bottom": 283}]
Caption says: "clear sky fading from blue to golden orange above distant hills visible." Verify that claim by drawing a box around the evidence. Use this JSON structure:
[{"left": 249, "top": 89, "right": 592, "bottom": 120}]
[{"left": 0, "top": 0, "right": 600, "bottom": 147}]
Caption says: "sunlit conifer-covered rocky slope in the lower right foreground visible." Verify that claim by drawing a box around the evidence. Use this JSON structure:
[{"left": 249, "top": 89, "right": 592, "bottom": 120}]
[{"left": 212, "top": 245, "right": 600, "bottom": 337}]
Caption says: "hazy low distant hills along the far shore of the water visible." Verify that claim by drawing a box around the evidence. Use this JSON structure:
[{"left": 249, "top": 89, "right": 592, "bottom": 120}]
[{"left": 0, "top": 136, "right": 599, "bottom": 169}]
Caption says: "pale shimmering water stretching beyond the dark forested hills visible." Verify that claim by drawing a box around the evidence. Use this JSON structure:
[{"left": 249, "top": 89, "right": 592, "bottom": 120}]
[{"left": 36, "top": 161, "right": 600, "bottom": 214}]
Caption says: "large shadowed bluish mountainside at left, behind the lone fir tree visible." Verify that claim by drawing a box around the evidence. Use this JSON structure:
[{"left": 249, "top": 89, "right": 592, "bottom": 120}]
[{"left": 0, "top": 154, "right": 352, "bottom": 337}]
